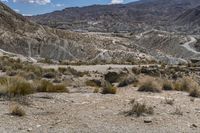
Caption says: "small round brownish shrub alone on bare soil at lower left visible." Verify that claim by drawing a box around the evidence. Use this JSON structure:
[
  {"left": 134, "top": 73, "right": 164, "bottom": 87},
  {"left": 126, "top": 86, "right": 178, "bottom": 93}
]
[{"left": 10, "top": 105, "right": 26, "bottom": 117}]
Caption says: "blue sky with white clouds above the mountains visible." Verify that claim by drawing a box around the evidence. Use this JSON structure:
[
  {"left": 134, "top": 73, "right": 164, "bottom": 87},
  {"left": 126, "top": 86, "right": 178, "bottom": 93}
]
[{"left": 0, "top": 0, "right": 137, "bottom": 16}]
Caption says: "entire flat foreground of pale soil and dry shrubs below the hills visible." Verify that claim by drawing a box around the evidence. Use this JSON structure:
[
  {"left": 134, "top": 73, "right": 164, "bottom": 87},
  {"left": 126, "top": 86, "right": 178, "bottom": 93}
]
[{"left": 0, "top": 54, "right": 200, "bottom": 133}]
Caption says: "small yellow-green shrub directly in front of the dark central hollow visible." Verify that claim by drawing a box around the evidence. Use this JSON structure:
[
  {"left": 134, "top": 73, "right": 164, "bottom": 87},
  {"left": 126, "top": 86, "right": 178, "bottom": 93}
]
[{"left": 101, "top": 81, "right": 117, "bottom": 94}]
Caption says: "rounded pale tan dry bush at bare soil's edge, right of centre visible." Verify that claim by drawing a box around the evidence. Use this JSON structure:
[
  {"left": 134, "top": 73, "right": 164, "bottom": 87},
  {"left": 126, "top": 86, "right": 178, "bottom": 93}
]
[{"left": 138, "top": 77, "right": 161, "bottom": 92}]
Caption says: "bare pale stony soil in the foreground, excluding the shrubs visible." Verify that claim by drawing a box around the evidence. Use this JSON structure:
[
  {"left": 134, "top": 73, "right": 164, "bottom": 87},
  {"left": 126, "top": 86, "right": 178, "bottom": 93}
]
[{"left": 0, "top": 86, "right": 200, "bottom": 133}]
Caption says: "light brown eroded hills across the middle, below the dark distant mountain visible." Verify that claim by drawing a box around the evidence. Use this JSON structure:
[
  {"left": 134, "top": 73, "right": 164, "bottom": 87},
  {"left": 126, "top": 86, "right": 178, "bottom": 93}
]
[{"left": 0, "top": 0, "right": 199, "bottom": 64}]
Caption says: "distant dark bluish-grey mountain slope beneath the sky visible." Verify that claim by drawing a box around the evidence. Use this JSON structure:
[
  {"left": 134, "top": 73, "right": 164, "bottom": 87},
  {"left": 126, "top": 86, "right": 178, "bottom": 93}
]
[{"left": 28, "top": 0, "right": 200, "bottom": 32}]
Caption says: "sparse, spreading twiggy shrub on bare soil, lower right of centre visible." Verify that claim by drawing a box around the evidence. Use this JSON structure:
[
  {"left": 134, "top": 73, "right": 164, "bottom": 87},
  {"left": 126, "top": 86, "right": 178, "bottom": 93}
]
[{"left": 125, "top": 99, "right": 154, "bottom": 117}]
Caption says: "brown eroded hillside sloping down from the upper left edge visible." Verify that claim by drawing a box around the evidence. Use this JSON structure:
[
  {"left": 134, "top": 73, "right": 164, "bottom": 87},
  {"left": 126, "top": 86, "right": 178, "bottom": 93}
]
[{"left": 0, "top": 3, "right": 155, "bottom": 62}]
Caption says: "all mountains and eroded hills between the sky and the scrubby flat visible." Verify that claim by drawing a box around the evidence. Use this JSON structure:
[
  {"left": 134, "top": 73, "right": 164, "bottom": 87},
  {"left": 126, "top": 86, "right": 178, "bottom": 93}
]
[{"left": 0, "top": 0, "right": 200, "bottom": 64}]
